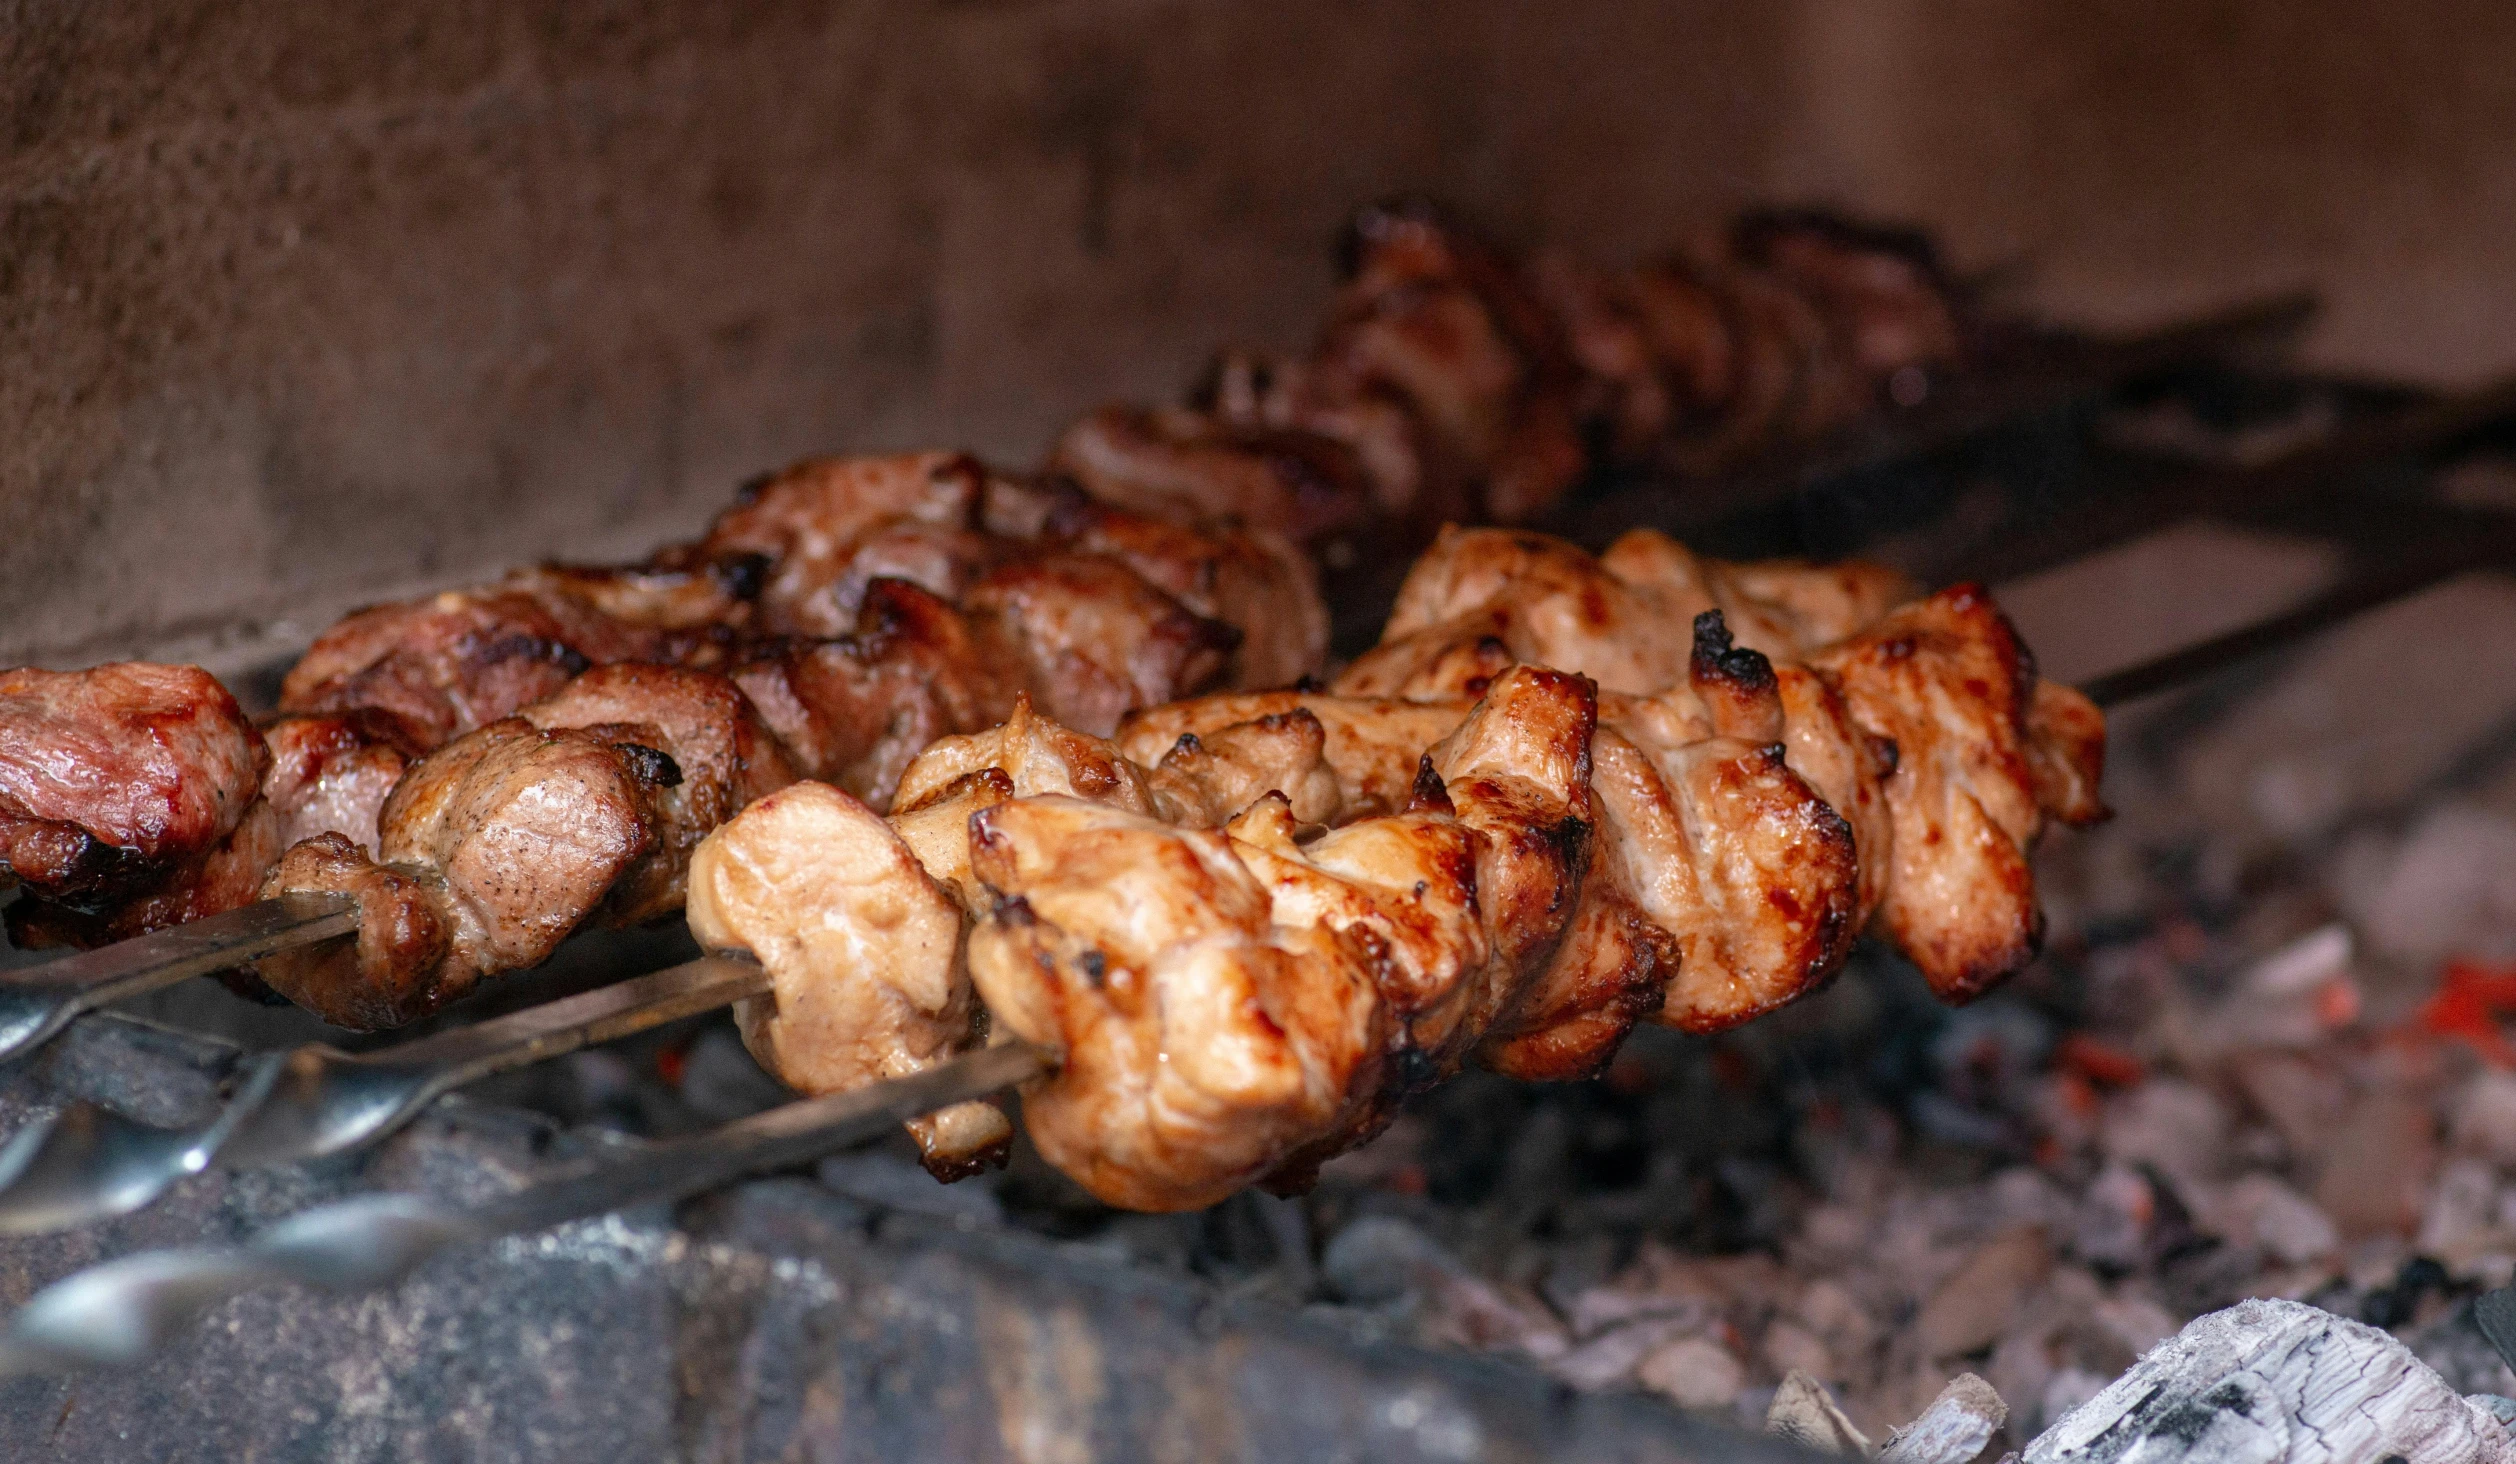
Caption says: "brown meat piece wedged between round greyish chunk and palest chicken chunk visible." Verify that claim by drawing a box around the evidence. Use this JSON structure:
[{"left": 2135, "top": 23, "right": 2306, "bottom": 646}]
[{"left": 518, "top": 664, "right": 795, "bottom": 926}]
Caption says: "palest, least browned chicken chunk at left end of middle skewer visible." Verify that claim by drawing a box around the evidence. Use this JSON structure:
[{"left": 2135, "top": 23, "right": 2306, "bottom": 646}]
[{"left": 689, "top": 782, "right": 1014, "bottom": 1180}]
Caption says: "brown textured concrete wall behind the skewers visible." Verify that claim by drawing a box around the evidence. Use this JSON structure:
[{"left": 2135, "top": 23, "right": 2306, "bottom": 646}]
[{"left": 0, "top": 0, "right": 2516, "bottom": 662}]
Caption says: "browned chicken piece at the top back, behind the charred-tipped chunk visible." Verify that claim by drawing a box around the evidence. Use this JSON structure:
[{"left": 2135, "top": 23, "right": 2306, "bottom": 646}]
[{"left": 1336, "top": 528, "right": 1910, "bottom": 699}]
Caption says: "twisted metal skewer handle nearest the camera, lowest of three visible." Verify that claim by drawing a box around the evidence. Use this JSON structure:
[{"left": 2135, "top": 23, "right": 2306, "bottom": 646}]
[{"left": 0, "top": 1041, "right": 1052, "bottom": 1376}]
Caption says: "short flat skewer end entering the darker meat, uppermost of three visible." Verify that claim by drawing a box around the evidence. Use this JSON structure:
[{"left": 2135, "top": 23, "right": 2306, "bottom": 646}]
[{"left": 0, "top": 896, "right": 357, "bottom": 1062}]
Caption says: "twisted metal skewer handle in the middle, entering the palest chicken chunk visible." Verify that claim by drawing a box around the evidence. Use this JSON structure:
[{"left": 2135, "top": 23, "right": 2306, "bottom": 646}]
[{"left": 0, "top": 956, "right": 770, "bottom": 1235}]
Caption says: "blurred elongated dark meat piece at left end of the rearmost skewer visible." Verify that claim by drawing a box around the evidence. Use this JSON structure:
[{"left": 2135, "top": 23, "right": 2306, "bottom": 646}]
[{"left": 1049, "top": 408, "right": 1371, "bottom": 543}]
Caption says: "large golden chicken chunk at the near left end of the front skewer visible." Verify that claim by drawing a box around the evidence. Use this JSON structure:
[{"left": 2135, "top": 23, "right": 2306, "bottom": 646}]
[{"left": 969, "top": 795, "right": 1381, "bottom": 1210}]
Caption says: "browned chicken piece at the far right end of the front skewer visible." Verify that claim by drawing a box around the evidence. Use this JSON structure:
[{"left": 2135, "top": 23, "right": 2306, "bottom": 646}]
[{"left": 1809, "top": 586, "right": 2103, "bottom": 1001}]
